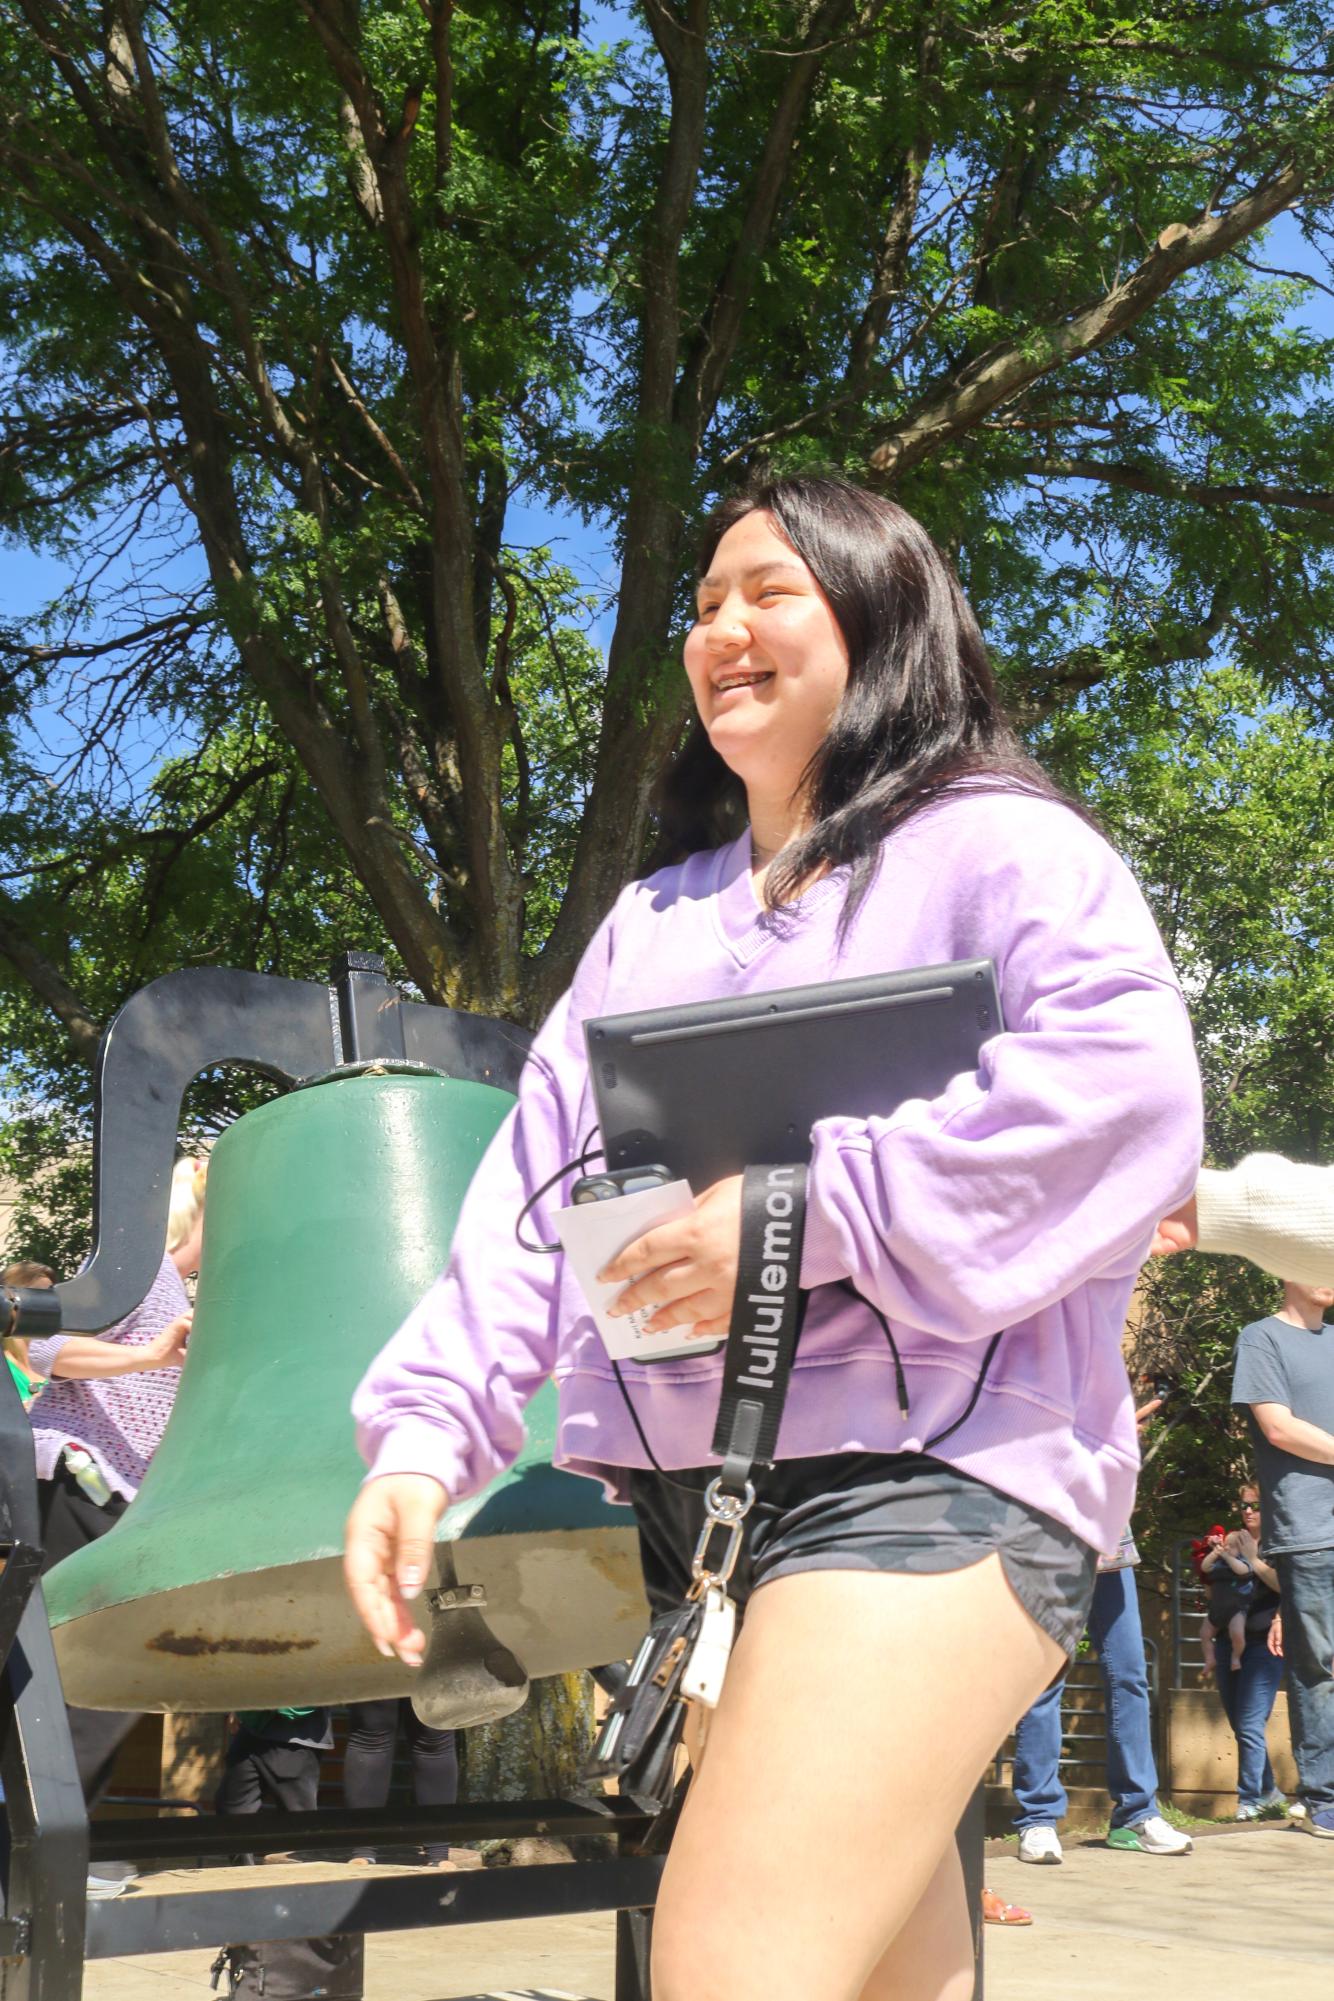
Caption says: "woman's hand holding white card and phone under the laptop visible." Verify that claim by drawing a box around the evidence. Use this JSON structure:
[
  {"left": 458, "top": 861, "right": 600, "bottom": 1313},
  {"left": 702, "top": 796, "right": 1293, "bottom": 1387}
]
[{"left": 598, "top": 1175, "right": 742, "bottom": 1339}]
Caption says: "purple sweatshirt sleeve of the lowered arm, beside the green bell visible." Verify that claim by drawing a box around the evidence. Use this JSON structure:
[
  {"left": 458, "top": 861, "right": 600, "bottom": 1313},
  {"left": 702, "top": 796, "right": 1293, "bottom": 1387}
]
[{"left": 352, "top": 918, "right": 610, "bottom": 1501}]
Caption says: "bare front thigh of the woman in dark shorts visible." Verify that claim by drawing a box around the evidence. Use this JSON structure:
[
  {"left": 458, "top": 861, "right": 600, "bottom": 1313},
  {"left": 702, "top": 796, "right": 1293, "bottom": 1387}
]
[{"left": 654, "top": 1555, "right": 1064, "bottom": 2001}]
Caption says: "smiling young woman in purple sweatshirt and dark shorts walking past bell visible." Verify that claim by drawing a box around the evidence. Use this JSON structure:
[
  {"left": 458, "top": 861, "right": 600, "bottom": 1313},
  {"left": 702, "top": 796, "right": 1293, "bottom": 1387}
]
[{"left": 348, "top": 478, "right": 1200, "bottom": 2001}]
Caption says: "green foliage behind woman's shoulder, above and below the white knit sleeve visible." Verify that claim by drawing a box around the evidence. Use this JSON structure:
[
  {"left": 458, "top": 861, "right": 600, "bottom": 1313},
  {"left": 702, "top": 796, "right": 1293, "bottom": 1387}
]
[{"left": 1042, "top": 666, "right": 1334, "bottom": 1565}]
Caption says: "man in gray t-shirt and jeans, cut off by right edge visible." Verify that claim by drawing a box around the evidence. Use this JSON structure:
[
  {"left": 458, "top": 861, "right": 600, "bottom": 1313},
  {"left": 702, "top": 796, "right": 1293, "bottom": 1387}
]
[{"left": 1232, "top": 1283, "right": 1334, "bottom": 1841}]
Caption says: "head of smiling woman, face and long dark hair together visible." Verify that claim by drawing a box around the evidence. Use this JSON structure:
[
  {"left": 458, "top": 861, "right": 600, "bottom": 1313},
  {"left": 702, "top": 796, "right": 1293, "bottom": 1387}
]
[{"left": 654, "top": 478, "right": 1082, "bottom": 922}]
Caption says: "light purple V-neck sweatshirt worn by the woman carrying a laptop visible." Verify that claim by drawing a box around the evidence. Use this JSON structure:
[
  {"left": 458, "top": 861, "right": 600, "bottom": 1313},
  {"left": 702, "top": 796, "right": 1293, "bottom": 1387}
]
[{"left": 354, "top": 786, "right": 1200, "bottom": 1551}]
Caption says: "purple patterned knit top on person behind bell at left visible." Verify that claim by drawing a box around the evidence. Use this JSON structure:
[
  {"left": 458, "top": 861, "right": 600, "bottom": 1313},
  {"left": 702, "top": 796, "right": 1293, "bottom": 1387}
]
[{"left": 28, "top": 1257, "right": 190, "bottom": 1501}]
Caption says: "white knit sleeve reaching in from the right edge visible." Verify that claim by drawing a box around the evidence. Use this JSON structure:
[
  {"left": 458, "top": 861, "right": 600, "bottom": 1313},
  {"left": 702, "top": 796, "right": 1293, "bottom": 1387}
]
[{"left": 1196, "top": 1153, "right": 1334, "bottom": 1285}]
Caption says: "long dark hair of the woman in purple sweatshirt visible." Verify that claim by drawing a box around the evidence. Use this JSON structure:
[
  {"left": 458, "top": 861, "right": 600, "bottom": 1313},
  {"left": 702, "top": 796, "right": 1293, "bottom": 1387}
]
[{"left": 654, "top": 474, "right": 1082, "bottom": 926}]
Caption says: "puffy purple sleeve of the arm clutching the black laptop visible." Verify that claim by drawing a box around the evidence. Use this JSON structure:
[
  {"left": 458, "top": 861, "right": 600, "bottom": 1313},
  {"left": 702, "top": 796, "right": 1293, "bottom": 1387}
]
[{"left": 802, "top": 800, "right": 1202, "bottom": 1341}]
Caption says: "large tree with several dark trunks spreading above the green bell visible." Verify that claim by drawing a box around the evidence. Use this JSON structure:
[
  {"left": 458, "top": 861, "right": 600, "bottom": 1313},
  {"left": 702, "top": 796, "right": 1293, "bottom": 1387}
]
[{"left": 0, "top": 0, "right": 1334, "bottom": 1053}]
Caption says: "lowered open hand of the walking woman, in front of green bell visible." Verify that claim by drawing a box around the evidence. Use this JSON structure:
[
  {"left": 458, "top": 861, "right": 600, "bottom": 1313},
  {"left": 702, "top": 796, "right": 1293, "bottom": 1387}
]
[{"left": 342, "top": 1473, "right": 448, "bottom": 1667}]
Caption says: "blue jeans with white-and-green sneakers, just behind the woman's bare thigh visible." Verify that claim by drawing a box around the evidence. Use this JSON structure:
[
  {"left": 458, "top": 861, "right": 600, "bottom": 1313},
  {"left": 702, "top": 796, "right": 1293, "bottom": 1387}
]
[{"left": 1014, "top": 1571, "right": 1158, "bottom": 1829}]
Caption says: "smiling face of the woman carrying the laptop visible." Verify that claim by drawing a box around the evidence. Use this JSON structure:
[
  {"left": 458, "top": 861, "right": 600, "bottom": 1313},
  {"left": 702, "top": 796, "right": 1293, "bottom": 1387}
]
[{"left": 686, "top": 510, "right": 848, "bottom": 804}]
